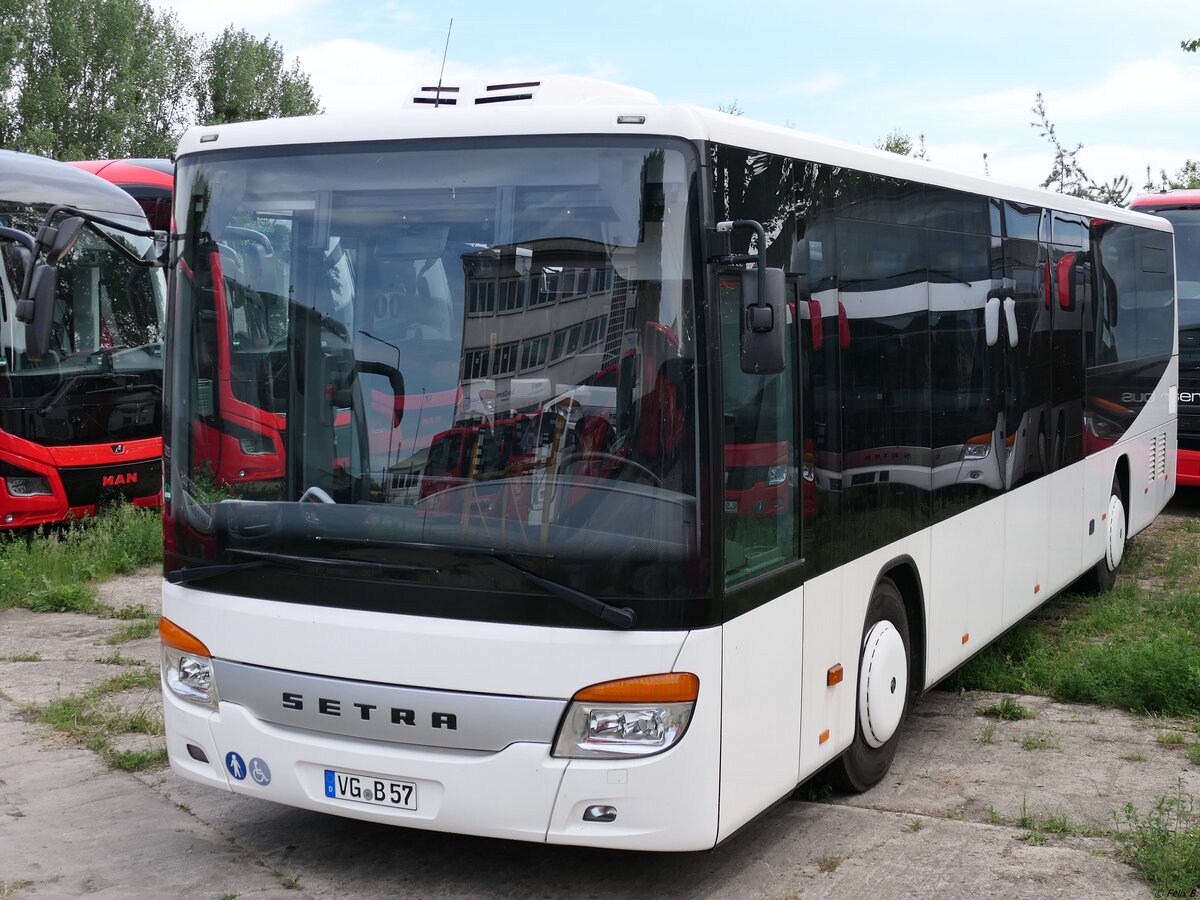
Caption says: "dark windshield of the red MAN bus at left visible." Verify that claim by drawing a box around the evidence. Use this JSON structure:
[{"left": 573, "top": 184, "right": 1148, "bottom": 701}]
[{"left": 0, "top": 204, "right": 166, "bottom": 446}]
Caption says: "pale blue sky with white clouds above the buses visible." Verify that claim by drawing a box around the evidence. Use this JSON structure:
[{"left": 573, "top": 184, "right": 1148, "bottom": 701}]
[{"left": 152, "top": 0, "right": 1200, "bottom": 196}]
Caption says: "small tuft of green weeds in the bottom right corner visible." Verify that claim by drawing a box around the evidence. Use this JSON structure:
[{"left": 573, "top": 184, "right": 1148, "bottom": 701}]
[{"left": 1114, "top": 779, "right": 1200, "bottom": 896}]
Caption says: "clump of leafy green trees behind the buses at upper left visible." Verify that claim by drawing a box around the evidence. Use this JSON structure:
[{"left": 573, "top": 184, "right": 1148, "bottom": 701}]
[{"left": 0, "top": 0, "right": 320, "bottom": 160}]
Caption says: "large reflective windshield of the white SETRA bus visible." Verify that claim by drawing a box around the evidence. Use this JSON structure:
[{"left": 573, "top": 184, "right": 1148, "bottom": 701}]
[{"left": 167, "top": 138, "right": 701, "bottom": 609}]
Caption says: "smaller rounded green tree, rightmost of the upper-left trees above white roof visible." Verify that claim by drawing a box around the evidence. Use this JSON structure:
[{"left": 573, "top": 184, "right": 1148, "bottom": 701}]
[{"left": 196, "top": 25, "right": 320, "bottom": 125}]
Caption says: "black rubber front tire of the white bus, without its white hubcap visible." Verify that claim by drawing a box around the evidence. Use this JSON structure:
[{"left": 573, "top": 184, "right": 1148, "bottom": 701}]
[{"left": 829, "top": 578, "right": 913, "bottom": 793}]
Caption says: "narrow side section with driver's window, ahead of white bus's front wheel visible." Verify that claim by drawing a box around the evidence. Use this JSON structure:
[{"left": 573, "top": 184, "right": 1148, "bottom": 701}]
[{"left": 716, "top": 271, "right": 804, "bottom": 836}]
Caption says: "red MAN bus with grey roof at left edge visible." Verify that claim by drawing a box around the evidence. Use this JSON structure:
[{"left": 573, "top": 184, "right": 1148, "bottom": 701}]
[{"left": 0, "top": 151, "right": 166, "bottom": 528}]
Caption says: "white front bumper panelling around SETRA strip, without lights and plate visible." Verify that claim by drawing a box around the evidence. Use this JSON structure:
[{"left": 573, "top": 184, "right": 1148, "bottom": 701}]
[{"left": 163, "top": 584, "right": 720, "bottom": 851}]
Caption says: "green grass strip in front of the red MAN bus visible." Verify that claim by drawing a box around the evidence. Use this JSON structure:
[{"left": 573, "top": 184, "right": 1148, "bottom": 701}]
[{"left": 0, "top": 505, "right": 162, "bottom": 618}]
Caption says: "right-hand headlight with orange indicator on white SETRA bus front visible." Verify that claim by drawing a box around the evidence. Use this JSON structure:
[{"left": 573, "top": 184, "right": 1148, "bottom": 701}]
[{"left": 554, "top": 672, "right": 700, "bottom": 758}]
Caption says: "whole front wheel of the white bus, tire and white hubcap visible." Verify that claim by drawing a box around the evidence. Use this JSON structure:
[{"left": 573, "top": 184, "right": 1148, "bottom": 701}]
[{"left": 830, "top": 577, "right": 911, "bottom": 793}]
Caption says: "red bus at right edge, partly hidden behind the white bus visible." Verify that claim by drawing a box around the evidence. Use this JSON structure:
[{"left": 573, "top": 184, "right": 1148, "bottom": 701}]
[{"left": 1129, "top": 190, "right": 1200, "bottom": 487}]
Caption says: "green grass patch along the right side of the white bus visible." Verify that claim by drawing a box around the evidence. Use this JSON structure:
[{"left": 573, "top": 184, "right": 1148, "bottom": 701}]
[{"left": 947, "top": 520, "right": 1200, "bottom": 716}]
